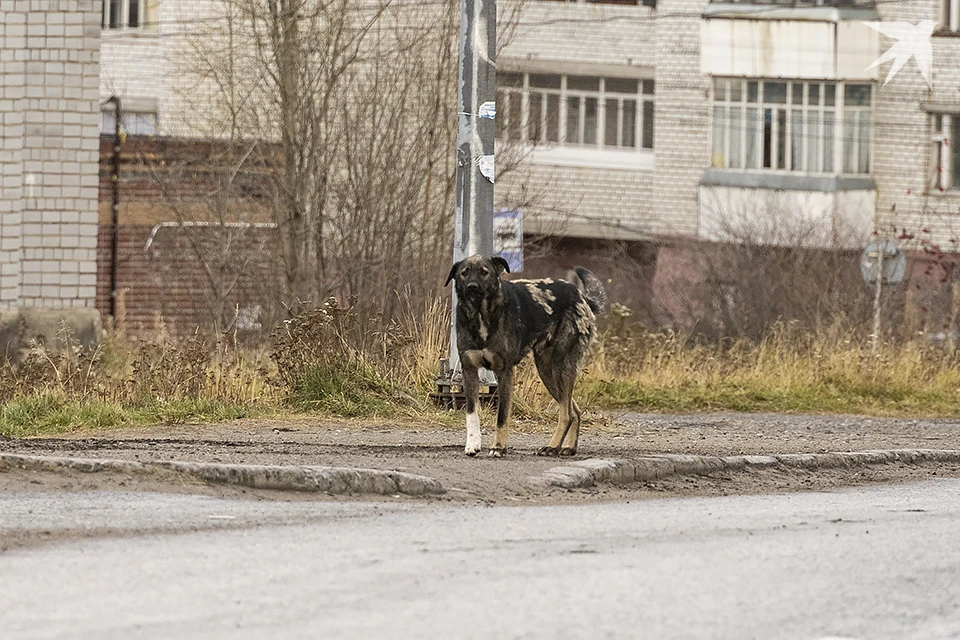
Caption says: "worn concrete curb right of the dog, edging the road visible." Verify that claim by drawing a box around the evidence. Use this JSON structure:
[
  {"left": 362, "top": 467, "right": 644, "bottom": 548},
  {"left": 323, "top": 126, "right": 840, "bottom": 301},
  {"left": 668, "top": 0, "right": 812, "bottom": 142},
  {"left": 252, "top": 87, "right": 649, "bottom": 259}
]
[{"left": 528, "top": 449, "right": 960, "bottom": 489}]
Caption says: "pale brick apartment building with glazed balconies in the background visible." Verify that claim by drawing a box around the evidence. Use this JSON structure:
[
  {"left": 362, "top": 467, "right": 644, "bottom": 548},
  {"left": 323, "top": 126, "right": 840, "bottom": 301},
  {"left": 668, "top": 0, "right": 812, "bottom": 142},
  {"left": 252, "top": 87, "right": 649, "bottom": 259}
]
[{"left": 95, "top": 0, "right": 960, "bottom": 330}]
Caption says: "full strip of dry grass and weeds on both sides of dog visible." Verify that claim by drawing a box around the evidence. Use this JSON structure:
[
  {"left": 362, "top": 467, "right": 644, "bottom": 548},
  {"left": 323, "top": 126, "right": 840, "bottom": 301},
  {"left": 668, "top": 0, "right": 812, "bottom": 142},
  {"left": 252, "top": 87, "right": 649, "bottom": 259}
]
[{"left": 0, "top": 301, "right": 960, "bottom": 436}]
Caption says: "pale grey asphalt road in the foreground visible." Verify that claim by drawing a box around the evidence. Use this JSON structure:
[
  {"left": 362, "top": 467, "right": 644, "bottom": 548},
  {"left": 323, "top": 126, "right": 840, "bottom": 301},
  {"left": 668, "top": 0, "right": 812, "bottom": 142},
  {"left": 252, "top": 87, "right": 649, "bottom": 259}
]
[{"left": 0, "top": 479, "right": 960, "bottom": 640}]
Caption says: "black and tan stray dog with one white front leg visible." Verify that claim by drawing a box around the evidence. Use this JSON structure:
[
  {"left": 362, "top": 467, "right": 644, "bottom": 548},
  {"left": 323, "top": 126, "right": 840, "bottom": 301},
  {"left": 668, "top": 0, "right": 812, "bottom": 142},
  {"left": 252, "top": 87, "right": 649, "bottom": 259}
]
[{"left": 445, "top": 255, "right": 607, "bottom": 457}]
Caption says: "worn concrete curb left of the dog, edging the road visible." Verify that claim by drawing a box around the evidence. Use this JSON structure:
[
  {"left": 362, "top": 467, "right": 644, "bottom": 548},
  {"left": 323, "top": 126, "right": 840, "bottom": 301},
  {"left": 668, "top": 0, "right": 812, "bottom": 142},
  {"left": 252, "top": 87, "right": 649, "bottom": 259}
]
[{"left": 0, "top": 453, "right": 444, "bottom": 496}]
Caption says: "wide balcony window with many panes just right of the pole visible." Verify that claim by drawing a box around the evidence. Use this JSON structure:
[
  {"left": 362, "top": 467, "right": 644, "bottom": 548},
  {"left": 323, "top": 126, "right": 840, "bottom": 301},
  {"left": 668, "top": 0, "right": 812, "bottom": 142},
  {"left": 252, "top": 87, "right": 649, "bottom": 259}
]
[{"left": 497, "top": 73, "right": 654, "bottom": 150}]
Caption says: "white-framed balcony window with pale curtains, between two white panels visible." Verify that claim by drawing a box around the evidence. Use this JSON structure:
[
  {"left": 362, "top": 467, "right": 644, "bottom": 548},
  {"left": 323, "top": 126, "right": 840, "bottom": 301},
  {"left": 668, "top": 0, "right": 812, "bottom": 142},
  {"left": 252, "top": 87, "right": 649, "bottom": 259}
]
[{"left": 711, "top": 78, "right": 873, "bottom": 174}]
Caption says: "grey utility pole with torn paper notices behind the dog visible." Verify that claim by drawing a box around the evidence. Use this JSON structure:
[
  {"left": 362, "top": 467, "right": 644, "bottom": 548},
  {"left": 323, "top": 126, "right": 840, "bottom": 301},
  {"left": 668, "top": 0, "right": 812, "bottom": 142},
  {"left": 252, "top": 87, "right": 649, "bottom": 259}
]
[{"left": 450, "top": 0, "right": 497, "bottom": 382}]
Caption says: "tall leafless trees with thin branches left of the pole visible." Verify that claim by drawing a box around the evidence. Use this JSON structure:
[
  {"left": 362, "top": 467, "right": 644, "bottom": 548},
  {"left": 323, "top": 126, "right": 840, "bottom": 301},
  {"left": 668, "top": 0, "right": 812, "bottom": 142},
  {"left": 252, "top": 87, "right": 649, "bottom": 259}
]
[{"left": 142, "top": 0, "right": 568, "bottom": 340}]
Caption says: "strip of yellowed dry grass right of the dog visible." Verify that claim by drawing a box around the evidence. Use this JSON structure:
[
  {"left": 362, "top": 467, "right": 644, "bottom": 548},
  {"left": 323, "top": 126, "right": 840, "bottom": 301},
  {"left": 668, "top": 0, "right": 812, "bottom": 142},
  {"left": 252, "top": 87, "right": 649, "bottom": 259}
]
[{"left": 581, "top": 318, "right": 960, "bottom": 416}]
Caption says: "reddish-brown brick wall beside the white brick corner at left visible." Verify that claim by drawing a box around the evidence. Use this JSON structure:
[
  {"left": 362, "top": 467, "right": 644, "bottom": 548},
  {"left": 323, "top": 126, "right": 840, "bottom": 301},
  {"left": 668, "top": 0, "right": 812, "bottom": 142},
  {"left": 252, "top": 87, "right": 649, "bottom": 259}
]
[{"left": 97, "top": 136, "right": 283, "bottom": 339}]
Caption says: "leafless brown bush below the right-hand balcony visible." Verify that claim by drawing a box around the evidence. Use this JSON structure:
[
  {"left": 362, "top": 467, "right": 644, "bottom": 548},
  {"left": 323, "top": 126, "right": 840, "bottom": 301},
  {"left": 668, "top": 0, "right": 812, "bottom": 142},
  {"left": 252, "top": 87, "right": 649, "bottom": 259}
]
[{"left": 658, "top": 189, "right": 876, "bottom": 340}]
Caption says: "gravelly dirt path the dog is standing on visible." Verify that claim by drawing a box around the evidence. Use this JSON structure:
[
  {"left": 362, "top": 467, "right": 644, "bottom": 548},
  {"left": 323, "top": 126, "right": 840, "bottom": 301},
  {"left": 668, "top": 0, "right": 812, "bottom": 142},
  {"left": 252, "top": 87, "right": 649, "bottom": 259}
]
[{"left": 0, "top": 413, "right": 960, "bottom": 502}]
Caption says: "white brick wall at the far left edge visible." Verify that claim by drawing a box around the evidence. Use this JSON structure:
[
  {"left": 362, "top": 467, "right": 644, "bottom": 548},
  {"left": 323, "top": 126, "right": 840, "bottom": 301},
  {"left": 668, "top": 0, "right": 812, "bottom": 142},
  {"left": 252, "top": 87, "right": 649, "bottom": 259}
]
[{"left": 0, "top": 0, "right": 100, "bottom": 310}]
